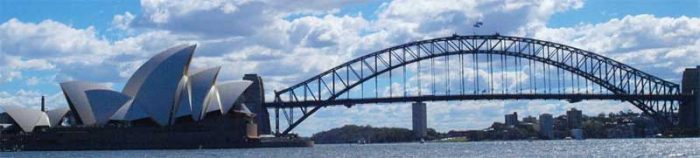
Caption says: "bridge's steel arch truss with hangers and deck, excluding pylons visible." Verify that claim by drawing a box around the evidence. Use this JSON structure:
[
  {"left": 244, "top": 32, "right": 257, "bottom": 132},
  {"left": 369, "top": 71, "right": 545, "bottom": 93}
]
[{"left": 266, "top": 35, "right": 684, "bottom": 134}]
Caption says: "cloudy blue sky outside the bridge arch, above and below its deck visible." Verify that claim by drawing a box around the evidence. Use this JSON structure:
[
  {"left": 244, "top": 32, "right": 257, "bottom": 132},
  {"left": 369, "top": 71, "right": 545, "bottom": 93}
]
[{"left": 0, "top": 0, "right": 700, "bottom": 136}]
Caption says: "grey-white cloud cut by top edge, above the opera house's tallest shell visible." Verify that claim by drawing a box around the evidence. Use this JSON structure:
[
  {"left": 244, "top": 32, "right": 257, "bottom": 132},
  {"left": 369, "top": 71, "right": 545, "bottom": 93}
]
[{"left": 133, "top": 1, "right": 274, "bottom": 37}]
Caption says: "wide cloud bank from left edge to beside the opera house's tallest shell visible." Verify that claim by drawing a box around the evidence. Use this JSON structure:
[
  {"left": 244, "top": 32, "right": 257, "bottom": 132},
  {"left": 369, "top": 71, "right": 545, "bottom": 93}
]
[{"left": 0, "top": 19, "right": 187, "bottom": 86}]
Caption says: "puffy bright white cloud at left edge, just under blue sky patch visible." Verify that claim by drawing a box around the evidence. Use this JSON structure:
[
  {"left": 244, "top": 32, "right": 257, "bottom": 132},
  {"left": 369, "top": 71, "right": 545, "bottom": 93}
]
[{"left": 0, "top": 19, "right": 111, "bottom": 62}]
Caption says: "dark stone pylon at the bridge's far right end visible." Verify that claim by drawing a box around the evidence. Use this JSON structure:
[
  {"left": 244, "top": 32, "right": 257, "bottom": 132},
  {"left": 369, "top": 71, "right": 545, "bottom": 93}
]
[{"left": 678, "top": 66, "right": 700, "bottom": 129}]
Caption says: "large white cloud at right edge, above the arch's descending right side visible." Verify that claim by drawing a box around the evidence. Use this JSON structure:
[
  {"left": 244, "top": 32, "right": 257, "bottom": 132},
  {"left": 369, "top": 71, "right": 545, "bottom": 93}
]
[{"left": 535, "top": 14, "right": 700, "bottom": 81}]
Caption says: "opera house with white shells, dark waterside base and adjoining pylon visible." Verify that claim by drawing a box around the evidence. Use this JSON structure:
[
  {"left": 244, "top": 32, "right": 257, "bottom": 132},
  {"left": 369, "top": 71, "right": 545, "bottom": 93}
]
[{"left": 0, "top": 45, "right": 311, "bottom": 151}]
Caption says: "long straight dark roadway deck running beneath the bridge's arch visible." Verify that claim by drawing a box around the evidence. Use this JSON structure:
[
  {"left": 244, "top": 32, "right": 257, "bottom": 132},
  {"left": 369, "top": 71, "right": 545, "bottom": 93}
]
[{"left": 265, "top": 94, "right": 692, "bottom": 108}]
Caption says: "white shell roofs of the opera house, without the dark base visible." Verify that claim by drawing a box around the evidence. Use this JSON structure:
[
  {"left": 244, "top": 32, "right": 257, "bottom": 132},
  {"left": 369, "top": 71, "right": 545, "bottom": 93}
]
[{"left": 1, "top": 45, "right": 252, "bottom": 132}]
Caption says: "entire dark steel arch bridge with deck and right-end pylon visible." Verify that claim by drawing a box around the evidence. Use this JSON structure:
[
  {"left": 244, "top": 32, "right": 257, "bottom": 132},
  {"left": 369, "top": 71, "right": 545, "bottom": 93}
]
[{"left": 265, "top": 34, "right": 700, "bottom": 135}]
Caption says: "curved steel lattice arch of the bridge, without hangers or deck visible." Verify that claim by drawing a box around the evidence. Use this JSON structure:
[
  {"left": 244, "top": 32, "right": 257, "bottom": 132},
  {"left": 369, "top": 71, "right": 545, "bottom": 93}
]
[{"left": 268, "top": 35, "right": 683, "bottom": 134}]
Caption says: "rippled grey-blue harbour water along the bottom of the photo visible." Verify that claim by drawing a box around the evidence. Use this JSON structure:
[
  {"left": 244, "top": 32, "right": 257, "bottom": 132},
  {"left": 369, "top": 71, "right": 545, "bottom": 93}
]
[{"left": 0, "top": 138, "right": 700, "bottom": 158}]
